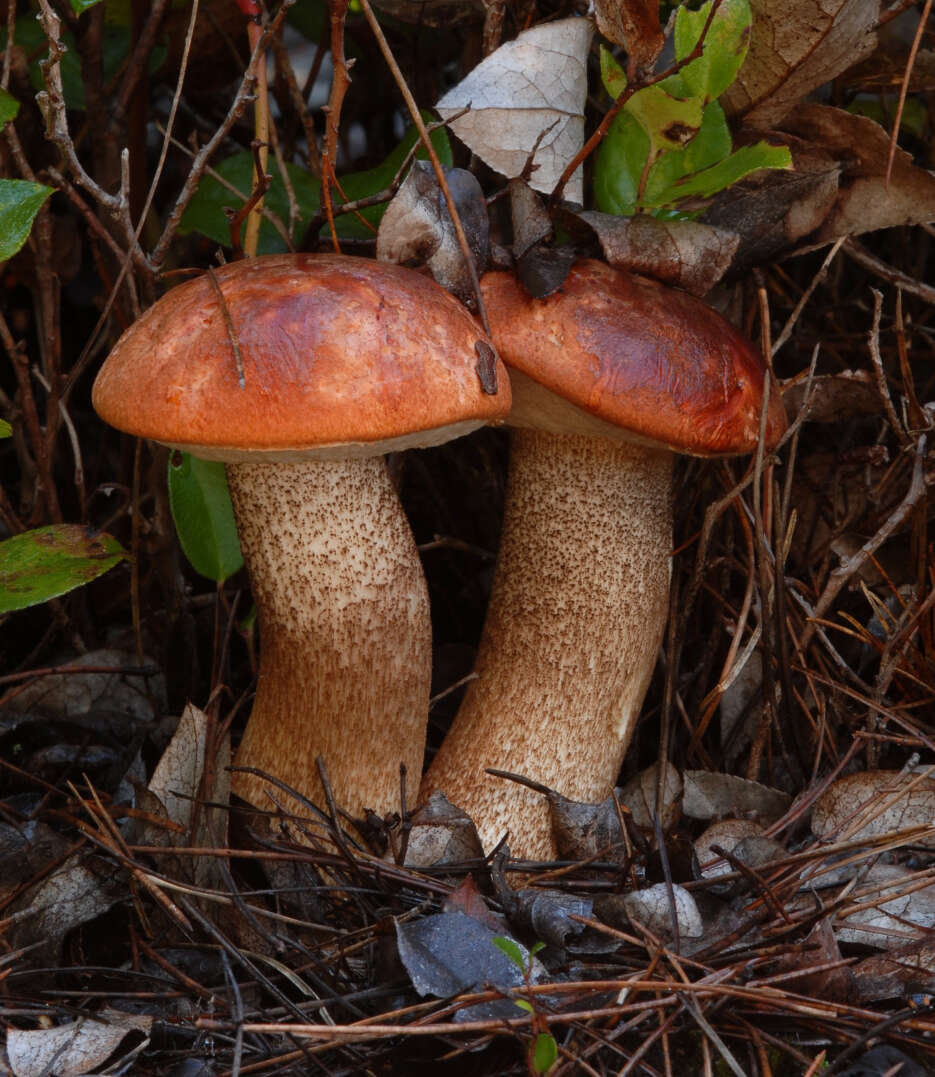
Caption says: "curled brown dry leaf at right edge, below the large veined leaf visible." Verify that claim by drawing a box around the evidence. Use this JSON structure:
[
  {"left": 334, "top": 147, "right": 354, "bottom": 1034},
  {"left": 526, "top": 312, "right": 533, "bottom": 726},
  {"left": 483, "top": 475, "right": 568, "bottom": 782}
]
[{"left": 783, "top": 104, "right": 935, "bottom": 244}]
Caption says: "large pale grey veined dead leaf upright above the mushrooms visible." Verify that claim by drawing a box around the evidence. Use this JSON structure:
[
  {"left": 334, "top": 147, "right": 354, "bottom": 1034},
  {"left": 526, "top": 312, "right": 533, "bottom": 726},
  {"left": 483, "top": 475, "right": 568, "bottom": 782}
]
[{"left": 436, "top": 18, "right": 594, "bottom": 201}]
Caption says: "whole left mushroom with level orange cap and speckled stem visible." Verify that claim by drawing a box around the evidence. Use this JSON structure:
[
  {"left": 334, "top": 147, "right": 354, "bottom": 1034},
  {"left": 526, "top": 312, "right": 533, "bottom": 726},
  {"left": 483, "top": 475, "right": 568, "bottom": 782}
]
[{"left": 94, "top": 254, "right": 510, "bottom": 815}]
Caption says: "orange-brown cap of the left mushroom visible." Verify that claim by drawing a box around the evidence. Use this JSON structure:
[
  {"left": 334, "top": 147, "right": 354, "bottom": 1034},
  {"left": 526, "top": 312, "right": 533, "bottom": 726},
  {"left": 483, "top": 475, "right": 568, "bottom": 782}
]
[{"left": 93, "top": 254, "right": 511, "bottom": 462}]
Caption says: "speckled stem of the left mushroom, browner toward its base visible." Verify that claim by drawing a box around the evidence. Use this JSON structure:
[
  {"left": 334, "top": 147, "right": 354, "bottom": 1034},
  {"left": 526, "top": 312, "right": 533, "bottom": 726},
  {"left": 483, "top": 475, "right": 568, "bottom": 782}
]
[{"left": 227, "top": 457, "right": 431, "bottom": 816}]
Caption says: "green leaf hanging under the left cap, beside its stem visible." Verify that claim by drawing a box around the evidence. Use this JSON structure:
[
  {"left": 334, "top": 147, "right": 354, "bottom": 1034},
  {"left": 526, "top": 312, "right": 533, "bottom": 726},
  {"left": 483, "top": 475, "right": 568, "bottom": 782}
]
[{"left": 169, "top": 451, "right": 243, "bottom": 584}]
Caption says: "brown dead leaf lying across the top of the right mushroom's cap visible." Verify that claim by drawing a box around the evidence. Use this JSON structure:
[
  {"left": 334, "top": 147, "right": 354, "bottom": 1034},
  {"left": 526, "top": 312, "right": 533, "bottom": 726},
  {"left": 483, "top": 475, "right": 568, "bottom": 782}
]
[{"left": 562, "top": 210, "right": 740, "bottom": 296}]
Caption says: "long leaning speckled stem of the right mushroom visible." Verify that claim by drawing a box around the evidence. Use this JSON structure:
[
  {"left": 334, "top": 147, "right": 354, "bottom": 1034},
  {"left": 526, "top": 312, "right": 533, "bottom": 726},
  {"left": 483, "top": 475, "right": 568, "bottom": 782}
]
[{"left": 421, "top": 430, "right": 672, "bottom": 859}]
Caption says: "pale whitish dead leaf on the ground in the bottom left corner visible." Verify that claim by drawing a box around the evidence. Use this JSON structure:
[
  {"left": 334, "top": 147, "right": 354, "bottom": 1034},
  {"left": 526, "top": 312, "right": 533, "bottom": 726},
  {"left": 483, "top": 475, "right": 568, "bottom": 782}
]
[{"left": 6, "top": 1010, "right": 153, "bottom": 1077}]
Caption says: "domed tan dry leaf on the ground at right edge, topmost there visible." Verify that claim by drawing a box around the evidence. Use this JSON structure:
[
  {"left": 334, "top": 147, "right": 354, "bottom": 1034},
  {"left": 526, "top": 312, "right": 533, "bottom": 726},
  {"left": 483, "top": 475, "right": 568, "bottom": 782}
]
[{"left": 811, "top": 770, "right": 935, "bottom": 849}]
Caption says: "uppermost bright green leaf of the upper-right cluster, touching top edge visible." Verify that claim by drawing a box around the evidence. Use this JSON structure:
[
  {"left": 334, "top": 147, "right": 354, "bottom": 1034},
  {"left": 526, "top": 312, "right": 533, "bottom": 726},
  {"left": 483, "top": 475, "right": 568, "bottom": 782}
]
[{"left": 674, "top": 0, "right": 753, "bottom": 104}]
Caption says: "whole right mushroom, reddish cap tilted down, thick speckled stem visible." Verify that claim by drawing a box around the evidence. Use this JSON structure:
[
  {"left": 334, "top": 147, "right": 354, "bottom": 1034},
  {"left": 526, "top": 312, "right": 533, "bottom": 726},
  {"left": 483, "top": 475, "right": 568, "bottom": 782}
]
[{"left": 420, "top": 261, "right": 785, "bottom": 859}]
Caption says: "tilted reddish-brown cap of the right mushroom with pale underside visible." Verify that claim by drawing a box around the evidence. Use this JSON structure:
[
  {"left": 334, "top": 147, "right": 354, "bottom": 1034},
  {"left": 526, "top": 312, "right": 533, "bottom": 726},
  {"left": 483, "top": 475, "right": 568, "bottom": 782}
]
[{"left": 482, "top": 260, "right": 786, "bottom": 456}]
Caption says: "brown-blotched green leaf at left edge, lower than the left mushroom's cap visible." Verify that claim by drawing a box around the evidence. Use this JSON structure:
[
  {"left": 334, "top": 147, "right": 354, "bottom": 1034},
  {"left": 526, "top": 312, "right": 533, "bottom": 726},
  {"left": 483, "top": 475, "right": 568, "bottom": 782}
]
[{"left": 0, "top": 523, "right": 127, "bottom": 613}]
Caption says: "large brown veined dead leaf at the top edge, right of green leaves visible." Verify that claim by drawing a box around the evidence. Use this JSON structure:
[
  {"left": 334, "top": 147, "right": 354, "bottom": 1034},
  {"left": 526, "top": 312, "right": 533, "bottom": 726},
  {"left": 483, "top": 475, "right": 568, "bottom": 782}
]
[{"left": 721, "top": 0, "right": 880, "bottom": 129}]
